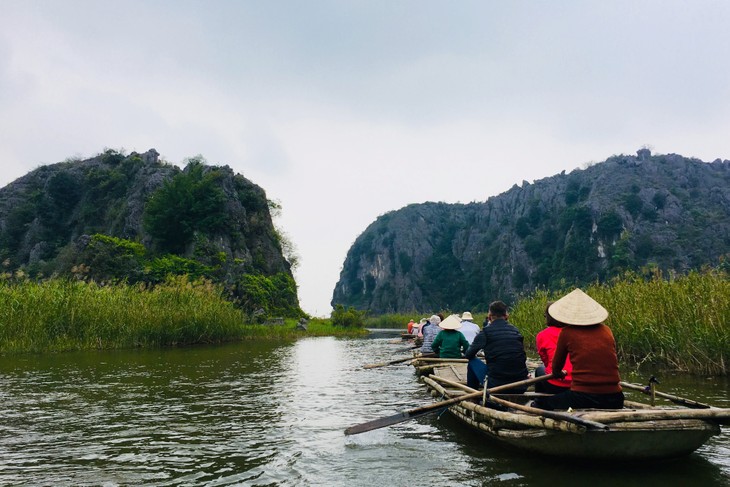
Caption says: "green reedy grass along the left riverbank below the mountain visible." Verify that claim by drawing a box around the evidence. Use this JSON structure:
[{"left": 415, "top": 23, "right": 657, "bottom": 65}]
[{"left": 0, "top": 278, "right": 366, "bottom": 353}]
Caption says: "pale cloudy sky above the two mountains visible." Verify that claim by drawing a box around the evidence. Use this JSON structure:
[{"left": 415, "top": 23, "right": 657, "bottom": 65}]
[{"left": 0, "top": 0, "right": 730, "bottom": 316}]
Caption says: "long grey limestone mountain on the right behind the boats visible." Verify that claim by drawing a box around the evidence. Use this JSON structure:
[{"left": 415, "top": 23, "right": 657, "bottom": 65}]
[{"left": 332, "top": 149, "right": 730, "bottom": 313}]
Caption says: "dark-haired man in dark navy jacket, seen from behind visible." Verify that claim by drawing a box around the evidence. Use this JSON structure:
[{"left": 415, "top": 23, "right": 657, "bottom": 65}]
[{"left": 464, "top": 301, "right": 527, "bottom": 394}]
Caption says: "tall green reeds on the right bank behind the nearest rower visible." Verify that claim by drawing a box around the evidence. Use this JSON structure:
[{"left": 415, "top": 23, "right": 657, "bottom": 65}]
[{"left": 510, "top": 269, "right": 730, "bottom": 374}]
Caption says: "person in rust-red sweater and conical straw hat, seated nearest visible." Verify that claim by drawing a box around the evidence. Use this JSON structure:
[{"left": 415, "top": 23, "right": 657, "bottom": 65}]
[{"left": 534, "top": 289, "right": 624, "bottom": 410}]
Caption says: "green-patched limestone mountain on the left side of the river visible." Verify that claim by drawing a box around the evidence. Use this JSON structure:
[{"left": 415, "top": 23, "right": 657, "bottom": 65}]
[{"left": 0, "top": 149, "right": 301, "bottom": 315}]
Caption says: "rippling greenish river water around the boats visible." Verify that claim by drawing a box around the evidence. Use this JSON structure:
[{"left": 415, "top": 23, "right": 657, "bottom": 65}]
[{"left": 0, "top": 332, "right": 730, "bottom": 487}]
